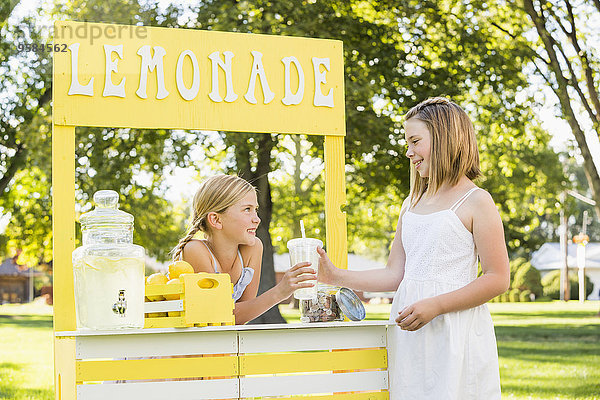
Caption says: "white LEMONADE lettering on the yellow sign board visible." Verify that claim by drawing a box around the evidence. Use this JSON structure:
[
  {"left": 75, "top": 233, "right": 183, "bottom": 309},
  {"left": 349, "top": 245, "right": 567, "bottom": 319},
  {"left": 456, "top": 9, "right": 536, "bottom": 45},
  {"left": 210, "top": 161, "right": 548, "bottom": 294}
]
[{"left": 68, "top": 43, "right": 334, "bottom": 108}]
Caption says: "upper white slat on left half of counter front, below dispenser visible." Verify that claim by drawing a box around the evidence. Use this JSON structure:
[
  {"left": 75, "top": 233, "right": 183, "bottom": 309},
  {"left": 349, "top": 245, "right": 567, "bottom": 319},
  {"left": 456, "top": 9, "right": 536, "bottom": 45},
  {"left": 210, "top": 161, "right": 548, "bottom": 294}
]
[{"left": 76, "top": 331, "right": 238, "bottom": 359}]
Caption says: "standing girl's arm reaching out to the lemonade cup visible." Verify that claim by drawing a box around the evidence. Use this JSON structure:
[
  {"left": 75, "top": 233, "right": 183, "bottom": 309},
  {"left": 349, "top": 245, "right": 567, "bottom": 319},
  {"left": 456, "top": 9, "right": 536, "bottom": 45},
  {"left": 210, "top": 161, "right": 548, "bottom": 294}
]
[{"left": 317, "top": 200, "right": 407, "bottom": 292}]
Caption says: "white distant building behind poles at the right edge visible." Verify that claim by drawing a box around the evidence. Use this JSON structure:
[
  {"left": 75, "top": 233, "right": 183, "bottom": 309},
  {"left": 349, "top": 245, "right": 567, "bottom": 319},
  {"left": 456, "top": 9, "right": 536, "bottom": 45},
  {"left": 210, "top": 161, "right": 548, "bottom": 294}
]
[{"left": 531, "top": 243, "right": 600, "bottom": 300}]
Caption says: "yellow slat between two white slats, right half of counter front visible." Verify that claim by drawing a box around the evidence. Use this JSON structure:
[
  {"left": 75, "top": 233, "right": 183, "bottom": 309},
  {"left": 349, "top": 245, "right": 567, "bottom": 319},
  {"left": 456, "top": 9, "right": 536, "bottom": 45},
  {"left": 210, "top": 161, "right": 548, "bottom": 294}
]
[{"left": 240, "top": 349, "right": 387, "bottom": 375}]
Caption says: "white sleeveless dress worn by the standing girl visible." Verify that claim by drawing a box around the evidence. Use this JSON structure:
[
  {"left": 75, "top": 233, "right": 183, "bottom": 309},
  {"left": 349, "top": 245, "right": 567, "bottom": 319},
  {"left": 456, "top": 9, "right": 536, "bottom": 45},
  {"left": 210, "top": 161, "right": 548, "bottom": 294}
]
[{"left": 389, "top": 188, "right": 500, "bottom": 400}]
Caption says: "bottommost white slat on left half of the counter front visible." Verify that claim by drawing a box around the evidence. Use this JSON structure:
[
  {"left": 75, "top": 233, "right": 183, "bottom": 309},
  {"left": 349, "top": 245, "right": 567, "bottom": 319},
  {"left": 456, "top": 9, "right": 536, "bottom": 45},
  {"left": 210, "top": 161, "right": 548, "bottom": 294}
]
[{"left": 77, "top": 379, "right": 239, "bottom": 400}]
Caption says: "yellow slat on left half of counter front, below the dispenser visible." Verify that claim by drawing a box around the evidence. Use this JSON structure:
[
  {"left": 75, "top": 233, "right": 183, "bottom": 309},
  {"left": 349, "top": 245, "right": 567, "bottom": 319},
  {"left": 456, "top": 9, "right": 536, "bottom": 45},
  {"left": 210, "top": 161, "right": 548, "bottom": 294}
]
[{"left": 77, "top": 355, "right": 238, "bottom": 381}]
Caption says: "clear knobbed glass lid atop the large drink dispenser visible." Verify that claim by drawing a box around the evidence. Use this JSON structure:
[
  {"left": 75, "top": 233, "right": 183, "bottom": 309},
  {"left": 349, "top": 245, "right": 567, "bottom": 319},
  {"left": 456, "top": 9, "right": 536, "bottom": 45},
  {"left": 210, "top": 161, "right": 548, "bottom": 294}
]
[{"left": 79, "top": 190, "right": 133, "bottom": 229}]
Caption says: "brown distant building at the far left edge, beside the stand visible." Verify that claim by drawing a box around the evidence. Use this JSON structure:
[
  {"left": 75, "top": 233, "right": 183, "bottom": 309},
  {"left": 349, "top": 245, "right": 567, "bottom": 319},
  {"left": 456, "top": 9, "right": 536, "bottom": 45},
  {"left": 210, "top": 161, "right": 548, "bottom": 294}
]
[{"left": 0, "top": 257, "right": 37, "bottom": 304}]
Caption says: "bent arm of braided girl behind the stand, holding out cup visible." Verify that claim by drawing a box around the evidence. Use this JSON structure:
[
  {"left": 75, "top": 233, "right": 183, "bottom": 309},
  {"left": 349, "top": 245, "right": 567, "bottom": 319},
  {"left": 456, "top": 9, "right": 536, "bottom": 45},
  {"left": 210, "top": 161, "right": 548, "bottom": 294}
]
[{"left": 233, "top": 238, "right": 316, "bottom": 325}]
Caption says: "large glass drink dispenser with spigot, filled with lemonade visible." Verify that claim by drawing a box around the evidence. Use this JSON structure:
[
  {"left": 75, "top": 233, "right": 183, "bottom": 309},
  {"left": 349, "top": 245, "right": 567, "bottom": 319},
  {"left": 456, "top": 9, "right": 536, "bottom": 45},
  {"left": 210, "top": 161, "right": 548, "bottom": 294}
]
[{"left": 73, "top": 190, "right": 144, "bottom": 329}]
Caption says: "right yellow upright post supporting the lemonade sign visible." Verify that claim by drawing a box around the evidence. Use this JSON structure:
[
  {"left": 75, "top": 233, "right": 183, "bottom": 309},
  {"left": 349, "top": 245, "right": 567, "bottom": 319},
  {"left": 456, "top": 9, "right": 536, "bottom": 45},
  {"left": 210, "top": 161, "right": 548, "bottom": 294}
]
[{"left": 325, "top": 136, "right": 348, "bottom": 269}]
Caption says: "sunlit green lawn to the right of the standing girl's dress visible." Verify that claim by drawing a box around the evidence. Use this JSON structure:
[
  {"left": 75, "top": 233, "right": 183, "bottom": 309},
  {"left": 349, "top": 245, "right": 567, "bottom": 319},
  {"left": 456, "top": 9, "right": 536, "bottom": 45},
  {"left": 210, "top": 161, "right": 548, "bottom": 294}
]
[{"left": 490, "top": 302, "right": 600, "bottom": 400}]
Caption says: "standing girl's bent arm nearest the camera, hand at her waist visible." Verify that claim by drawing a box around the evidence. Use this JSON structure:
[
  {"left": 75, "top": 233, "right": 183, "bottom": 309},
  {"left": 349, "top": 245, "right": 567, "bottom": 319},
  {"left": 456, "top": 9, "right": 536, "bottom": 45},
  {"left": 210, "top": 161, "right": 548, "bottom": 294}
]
[{"left": 396, "top": 190, "right": 510, "bottom": 331}]
